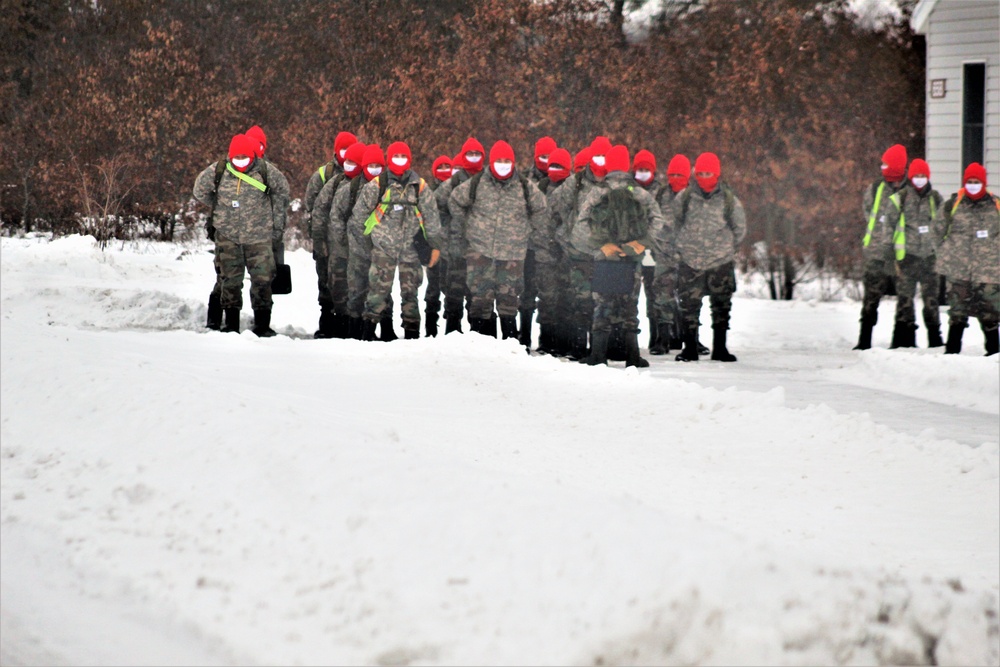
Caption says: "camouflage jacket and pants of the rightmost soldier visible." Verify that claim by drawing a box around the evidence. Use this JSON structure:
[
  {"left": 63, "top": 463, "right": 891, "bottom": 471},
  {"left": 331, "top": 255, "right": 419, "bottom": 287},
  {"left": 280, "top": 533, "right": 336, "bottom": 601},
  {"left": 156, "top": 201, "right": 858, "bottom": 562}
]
[{"left": 937, "top": 192, "right": 1000, "bottom": 338}]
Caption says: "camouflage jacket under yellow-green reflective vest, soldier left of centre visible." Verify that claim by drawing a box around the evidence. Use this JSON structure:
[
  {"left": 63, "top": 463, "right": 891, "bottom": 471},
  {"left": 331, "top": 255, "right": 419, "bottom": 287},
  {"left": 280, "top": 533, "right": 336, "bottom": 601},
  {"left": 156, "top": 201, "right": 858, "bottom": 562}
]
[{"left": 348, "top": 170, "right": 444, "bottom": 262}]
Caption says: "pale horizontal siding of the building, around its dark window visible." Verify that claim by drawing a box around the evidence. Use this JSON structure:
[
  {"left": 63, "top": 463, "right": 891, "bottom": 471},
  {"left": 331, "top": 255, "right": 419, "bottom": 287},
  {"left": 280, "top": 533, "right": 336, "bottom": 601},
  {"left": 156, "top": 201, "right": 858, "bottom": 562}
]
[{"left": 926, "top": 0, "right": 1000, "bottom": 196}]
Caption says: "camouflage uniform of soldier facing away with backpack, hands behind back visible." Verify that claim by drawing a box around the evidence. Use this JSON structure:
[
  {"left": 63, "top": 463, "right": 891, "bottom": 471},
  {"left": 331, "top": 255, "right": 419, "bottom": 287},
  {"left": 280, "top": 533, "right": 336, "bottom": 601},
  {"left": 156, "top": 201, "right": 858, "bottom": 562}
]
[{"left": 576, "top": 171, "right": 666, "bottom": 333}]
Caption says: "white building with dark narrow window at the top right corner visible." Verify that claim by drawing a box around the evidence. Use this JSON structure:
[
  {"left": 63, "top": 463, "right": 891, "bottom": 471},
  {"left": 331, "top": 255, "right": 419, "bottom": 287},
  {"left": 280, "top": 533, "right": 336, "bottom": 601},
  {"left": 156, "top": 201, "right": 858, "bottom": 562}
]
[{"left": 910, "top": 0, "right": 1000, "bottom": 197}]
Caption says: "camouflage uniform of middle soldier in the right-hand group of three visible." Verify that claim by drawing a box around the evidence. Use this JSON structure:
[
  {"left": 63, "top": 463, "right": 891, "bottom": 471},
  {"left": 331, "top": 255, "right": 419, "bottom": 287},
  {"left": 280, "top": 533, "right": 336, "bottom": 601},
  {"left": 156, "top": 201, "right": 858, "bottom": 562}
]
[{"left": 890, "top": 183, "right": 944, "bottom": 338}]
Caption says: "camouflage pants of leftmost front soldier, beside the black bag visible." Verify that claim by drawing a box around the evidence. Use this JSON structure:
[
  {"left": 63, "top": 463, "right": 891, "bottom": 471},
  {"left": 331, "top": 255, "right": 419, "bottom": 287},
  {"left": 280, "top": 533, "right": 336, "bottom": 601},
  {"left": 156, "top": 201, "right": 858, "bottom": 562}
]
[{"left": 215, "top": 234, "right": 275, "bottom": 310}]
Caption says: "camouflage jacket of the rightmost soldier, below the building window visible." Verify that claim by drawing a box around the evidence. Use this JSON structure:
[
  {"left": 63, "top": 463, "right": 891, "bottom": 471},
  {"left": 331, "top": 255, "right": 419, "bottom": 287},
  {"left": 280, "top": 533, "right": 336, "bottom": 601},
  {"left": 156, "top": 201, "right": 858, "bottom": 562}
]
[{"left": 937, "top": 192, "right": 1000, "bottom": 285}]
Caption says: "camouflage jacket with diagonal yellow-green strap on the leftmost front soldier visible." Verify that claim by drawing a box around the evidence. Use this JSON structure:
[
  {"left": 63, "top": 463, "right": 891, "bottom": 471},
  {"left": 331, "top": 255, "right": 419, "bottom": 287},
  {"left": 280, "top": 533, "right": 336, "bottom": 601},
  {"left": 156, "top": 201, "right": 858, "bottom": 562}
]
[{"left": 194, "top": 161, "right": 289, "bottom": 243}]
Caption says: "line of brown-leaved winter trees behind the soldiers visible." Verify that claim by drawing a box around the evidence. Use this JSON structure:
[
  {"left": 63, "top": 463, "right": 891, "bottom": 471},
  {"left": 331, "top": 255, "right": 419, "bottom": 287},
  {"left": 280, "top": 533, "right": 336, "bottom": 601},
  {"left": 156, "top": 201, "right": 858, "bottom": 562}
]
[{"left": 0, "top": 0, "right": 924, "bottom": 298}]
